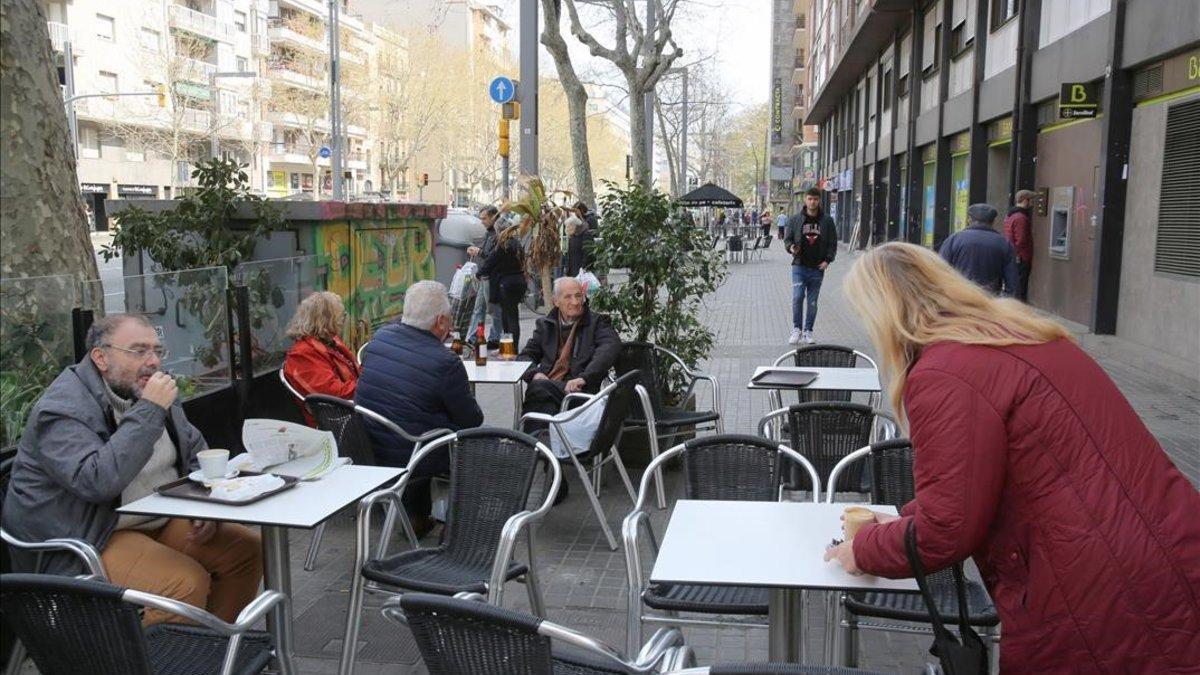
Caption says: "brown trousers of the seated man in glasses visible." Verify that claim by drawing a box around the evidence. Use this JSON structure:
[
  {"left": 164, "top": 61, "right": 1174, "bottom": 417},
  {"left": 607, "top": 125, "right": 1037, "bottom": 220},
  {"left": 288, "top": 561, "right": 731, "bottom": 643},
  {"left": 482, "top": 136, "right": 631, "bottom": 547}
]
[{"left": 100, "top": 519, "right": 263, "bottom": 626}]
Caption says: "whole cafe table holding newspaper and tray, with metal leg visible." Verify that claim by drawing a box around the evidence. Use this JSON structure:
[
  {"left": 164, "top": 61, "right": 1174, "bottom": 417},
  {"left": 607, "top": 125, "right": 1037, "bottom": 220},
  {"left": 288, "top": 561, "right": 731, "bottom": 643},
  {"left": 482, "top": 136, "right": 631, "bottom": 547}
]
[{"left": 116, "top": 465, "right": 403, "bottom": 675}]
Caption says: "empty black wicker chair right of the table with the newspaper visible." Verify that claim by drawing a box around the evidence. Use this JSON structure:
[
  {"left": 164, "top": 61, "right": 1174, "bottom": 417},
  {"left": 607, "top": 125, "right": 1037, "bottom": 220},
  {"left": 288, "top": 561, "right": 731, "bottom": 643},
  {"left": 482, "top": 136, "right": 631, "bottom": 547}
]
[{"left": 338, "top": 428, "right": 563, "bottom": 675}]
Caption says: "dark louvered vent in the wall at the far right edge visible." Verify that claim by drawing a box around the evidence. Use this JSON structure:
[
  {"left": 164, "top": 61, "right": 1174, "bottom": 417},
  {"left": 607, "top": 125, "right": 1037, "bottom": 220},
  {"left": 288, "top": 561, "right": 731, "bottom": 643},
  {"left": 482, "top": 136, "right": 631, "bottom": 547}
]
[{"left": 1154, "top": 96, "right": 1200, "bottom": 279}]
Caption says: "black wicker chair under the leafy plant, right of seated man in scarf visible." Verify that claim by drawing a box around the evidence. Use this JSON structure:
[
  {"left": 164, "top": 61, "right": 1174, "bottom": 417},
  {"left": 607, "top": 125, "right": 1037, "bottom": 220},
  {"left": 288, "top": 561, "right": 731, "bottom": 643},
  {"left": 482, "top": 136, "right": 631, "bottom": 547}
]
[{"left": 613, "top": 342, "right": 725, "bottom": 508}]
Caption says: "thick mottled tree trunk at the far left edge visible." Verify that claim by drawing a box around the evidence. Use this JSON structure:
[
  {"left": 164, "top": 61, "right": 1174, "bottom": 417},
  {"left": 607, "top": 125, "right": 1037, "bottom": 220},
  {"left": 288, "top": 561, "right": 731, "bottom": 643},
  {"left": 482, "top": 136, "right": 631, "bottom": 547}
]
[{"left": 0, "top": 0, "right": 100, "bottom": 280}]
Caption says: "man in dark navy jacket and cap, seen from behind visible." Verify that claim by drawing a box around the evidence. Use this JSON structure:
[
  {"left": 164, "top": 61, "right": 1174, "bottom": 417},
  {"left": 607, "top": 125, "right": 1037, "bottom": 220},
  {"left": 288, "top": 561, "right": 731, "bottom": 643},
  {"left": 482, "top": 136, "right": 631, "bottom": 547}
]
[{"left": 938, "top": 204, "right": 1018, "bottom": 295}]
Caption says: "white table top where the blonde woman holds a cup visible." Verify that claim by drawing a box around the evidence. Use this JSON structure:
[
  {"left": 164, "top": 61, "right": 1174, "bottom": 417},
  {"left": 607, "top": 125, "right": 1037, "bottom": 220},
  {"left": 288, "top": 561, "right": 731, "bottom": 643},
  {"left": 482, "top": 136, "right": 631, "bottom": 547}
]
[{"left": 650, "top": 500, "right": 917, "bottom": 591}]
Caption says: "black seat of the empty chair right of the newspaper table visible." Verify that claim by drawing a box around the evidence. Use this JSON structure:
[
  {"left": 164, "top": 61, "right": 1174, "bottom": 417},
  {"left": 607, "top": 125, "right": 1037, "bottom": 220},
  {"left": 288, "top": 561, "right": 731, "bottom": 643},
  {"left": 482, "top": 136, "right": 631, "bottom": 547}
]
[{"left": 362, "top": 548, "right": 529, "bottom": 596}]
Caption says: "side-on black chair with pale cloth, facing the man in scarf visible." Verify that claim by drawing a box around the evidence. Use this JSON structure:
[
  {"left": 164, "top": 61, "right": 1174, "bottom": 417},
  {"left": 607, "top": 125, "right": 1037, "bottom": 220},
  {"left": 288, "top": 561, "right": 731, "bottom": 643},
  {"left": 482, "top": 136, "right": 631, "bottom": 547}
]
[{"left": 521, "top": 370, "right": 640, "bottom": 550}]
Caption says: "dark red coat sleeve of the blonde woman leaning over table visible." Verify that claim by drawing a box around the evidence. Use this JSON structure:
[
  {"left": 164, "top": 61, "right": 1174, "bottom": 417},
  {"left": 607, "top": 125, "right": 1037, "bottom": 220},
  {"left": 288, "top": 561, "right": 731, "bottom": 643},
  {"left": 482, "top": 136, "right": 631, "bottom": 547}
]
[{"left": 854, "top": 371, "right": 1008, "bottom": 578}]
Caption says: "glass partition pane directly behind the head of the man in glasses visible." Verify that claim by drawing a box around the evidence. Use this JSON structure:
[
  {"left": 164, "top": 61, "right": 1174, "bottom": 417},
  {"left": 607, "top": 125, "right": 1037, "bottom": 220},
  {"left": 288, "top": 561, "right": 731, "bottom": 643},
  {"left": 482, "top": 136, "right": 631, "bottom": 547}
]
[{"left": 84, "top": 267, "right": 232, "bottom": 400}]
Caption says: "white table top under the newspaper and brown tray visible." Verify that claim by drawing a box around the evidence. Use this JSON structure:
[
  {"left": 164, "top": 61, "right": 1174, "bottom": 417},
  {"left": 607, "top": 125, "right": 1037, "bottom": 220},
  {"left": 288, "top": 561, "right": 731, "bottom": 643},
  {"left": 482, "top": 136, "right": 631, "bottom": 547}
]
[{"left": 116, "top": 465, "right": 402, "bottom": 530}]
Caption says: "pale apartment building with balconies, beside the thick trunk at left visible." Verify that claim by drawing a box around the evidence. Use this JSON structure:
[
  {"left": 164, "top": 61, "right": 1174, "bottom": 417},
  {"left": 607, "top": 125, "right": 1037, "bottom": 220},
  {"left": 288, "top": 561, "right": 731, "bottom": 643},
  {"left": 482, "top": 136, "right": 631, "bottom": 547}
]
[{"left": 43, "top": 0, "right": 270, "bottom": 228}]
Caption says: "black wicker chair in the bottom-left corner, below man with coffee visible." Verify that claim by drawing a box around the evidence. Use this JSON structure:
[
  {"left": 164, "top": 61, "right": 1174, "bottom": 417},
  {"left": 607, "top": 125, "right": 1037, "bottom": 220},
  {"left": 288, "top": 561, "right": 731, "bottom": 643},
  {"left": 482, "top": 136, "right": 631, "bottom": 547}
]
[{"left": 0, "top": 574, "right": 289, "bottom": 675}]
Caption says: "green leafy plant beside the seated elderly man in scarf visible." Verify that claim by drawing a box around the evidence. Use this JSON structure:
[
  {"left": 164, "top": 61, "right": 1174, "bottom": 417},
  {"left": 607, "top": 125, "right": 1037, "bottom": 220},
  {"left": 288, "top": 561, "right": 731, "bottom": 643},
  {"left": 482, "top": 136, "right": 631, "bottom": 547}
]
[{"left": 592, "top": 181, "right": 727, "bottom": 402}]
